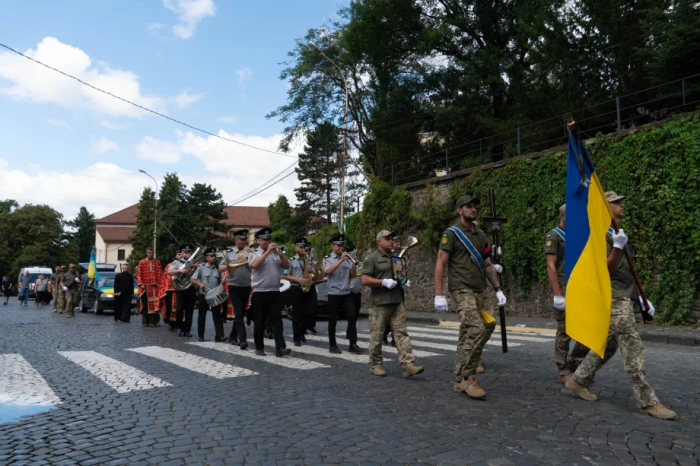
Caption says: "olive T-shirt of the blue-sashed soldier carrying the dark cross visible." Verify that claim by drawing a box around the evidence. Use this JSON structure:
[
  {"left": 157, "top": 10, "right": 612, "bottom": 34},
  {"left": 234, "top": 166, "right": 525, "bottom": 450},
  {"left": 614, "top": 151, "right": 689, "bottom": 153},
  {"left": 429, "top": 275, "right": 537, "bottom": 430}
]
[{"left": 440, "top": 220, "right": 491, "bottom": 293}]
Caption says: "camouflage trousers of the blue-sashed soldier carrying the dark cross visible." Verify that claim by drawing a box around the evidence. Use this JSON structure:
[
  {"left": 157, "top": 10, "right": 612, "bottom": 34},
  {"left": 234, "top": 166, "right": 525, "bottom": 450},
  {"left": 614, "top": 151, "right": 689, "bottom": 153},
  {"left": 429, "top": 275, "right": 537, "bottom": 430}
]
[{"left": 450, "top": 290, "right": 496, "bottom": 380}]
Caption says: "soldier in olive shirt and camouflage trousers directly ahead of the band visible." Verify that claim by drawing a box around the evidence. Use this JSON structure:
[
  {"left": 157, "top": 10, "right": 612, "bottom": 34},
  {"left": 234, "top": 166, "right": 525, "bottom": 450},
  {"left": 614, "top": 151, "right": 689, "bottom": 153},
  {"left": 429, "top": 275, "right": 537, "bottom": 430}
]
[{"left": 362, "top": 230, "right": 424, "bottom": 377}]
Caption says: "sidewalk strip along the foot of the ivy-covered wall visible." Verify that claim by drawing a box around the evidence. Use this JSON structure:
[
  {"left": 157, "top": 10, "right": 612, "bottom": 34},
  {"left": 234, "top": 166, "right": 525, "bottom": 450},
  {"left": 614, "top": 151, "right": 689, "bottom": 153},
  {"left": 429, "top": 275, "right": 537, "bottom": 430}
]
[{"left": 360, "top": 308, "right": 700, "bottom": 346}]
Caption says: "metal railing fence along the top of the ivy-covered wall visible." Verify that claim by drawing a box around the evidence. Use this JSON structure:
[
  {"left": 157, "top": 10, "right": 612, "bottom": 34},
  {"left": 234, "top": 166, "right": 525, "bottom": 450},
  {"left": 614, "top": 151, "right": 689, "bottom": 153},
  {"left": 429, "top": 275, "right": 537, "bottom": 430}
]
[{"left": 383, "top": 74, "right": 700, "bottom": 186}]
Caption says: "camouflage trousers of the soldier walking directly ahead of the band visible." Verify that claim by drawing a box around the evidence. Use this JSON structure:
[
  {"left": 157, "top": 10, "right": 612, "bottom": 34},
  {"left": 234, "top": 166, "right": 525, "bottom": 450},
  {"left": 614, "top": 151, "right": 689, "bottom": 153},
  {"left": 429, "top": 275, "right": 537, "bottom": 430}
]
[{"left": 369, "top": 303, "right": 413, "bottom": 368}]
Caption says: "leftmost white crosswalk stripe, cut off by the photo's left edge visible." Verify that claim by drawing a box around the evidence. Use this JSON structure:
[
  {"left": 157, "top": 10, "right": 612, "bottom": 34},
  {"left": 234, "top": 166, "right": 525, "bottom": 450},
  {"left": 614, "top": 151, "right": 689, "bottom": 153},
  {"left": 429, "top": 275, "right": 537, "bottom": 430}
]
[{"left": 0, "top": 354, "right": 61, "bottom": 406}]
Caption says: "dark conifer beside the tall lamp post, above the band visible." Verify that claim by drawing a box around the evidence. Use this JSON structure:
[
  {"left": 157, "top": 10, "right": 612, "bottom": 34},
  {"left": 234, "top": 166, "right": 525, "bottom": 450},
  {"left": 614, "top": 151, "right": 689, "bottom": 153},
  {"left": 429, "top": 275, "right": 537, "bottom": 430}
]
[{"left": 294, "top": 122, "right": 343, "bottom": 224}]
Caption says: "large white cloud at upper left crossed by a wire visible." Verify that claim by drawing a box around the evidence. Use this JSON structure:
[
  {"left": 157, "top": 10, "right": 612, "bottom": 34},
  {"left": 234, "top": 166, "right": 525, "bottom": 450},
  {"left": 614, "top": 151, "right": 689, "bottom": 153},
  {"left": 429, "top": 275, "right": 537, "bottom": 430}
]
[{"left": 0, "top": 37, "right": 166, "bottom": 118}]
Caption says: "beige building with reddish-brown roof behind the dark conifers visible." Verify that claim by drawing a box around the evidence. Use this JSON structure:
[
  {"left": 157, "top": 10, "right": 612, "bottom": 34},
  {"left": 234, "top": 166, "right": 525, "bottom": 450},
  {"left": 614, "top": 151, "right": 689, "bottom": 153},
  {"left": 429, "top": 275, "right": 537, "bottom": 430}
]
[{"left": 95, "top": 204, "right": 270, "bottom": 264}]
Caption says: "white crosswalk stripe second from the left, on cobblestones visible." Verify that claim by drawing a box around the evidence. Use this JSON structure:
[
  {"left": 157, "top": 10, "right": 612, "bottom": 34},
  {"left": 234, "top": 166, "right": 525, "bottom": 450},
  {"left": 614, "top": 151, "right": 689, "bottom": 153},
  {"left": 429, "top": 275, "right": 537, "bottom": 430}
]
[{"left": 58, "top": 351, "right": 170, "bottom": 393}]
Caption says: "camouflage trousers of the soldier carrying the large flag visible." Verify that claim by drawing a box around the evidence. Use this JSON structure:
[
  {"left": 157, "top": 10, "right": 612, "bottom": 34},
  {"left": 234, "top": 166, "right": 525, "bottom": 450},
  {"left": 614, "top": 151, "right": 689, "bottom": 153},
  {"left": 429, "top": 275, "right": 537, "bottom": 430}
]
[{"left": 573, "top": 298, "right": 659, "bottom": 408}]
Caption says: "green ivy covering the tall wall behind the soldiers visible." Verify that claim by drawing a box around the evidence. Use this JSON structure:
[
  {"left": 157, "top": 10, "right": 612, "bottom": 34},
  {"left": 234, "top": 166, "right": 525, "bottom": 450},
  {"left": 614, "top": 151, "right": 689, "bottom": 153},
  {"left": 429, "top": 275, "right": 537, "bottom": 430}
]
[{"left": 357, "top": 116, "right": 700, "bottom": 324}]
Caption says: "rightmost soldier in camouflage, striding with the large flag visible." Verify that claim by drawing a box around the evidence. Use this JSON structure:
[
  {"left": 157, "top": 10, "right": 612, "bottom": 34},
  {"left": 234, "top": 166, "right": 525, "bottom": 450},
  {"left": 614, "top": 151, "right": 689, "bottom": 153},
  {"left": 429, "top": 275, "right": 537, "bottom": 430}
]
[{"left": 565, "top": 191, "right": 676, "bottom": 419}]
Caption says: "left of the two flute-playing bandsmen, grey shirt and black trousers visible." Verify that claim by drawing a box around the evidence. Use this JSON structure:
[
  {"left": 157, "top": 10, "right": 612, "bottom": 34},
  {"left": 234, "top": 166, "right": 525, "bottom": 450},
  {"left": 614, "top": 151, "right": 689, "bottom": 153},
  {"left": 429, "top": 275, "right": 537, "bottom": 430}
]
[{"left": 248, "top": 227, "right": 291, "bottom": 357}]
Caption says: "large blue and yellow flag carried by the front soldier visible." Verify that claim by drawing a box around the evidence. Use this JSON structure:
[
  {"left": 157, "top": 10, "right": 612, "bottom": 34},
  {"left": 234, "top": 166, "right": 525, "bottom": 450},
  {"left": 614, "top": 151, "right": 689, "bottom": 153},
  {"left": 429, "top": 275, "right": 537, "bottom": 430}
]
[{"left": 564, "top": 128, "right": 613, "bottom": 358}]
